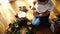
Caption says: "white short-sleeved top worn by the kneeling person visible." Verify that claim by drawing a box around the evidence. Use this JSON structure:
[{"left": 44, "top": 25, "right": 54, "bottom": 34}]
[{"left": 34, "top": 0, "right": 54, "bottom": 13}]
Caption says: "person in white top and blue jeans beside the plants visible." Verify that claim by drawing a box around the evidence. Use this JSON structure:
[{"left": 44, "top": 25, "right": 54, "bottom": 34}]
[{"left": 32, "top": 0, "right": 54, "bottom": 34}]
